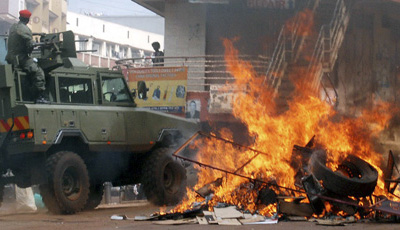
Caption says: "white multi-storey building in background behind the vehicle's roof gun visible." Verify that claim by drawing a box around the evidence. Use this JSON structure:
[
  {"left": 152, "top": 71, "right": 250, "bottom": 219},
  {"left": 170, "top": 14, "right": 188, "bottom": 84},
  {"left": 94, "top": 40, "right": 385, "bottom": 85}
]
[{"left": 67, "top": 12, "right": 164, "bottom": 68}]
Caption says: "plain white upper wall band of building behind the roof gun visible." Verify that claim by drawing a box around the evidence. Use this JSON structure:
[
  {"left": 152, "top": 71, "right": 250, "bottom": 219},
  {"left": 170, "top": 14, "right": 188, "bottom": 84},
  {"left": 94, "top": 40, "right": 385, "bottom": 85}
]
[{"left": 67, "top": 11, "right": 164, "bottom": 51}]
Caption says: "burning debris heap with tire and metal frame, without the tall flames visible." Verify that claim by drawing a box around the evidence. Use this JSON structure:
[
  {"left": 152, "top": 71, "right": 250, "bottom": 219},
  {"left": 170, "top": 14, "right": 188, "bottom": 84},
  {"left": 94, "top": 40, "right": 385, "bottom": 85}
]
[{"left": 156, "top": 132, "right": 400, "bottom": 225}]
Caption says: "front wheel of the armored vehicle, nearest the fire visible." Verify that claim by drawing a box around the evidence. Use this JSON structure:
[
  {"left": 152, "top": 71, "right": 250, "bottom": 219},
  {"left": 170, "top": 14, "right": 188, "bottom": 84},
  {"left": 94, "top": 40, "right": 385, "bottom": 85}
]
[{"left": 142, "top": 148, "right": 186, "bottom": 206}]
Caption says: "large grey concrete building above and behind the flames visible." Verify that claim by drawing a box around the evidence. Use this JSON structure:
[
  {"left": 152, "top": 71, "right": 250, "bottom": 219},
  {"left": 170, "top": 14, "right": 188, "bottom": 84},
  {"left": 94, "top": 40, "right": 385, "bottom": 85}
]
[{"left": 132, "top": 0, "right": 400, "bottom": 140}]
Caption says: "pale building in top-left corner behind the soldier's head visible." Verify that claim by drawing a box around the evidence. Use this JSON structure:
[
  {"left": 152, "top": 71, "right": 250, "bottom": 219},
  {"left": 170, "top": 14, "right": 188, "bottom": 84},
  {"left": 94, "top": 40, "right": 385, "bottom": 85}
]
[{"left": 0, "top": 0, "right": 68, "bottom": 34}]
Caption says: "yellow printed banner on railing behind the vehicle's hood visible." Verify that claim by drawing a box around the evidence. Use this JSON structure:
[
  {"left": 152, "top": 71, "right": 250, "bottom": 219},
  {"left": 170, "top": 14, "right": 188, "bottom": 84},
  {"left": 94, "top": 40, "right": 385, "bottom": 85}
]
[{"left": 127, "top": 67, "right": 187, "bottom": 113}]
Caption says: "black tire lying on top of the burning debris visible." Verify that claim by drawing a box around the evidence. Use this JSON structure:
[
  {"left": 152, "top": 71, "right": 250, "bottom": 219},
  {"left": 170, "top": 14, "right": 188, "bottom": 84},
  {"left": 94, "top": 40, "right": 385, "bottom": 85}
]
[{"left": 309, "top": 150, "right": 378, "bottom": 197}]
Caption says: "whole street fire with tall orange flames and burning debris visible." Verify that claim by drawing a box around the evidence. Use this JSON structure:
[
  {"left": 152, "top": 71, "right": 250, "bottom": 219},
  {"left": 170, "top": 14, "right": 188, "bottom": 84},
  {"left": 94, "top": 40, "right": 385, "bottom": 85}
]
[{"left": 140, "top": 35, "right": 400, "bottom": 224}]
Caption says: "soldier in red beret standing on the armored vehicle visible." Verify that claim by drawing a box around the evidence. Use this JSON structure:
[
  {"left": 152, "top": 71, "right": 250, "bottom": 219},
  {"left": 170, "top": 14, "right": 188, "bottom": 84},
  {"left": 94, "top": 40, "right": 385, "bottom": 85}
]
[{"left": 6, "top": 10, "right": 48, "bottom": 103}]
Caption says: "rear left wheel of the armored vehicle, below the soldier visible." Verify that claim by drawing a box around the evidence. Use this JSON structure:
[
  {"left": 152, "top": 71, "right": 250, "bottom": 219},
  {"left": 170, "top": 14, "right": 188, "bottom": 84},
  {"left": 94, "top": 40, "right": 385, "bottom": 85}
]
[{"left": 40, "top": 151, "right": 89, "bottom": 214}]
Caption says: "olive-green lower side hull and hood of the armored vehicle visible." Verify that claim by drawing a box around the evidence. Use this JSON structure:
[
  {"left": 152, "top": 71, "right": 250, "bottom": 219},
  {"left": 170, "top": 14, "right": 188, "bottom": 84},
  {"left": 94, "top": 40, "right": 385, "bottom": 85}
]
[{"left": 1, "top": 104, "right": 198, "bottom": 155}]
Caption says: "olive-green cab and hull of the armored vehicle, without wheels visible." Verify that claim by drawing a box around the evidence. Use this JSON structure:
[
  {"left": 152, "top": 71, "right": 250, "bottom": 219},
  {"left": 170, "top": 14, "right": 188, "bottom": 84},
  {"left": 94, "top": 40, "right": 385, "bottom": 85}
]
[{"left": 0, "top": 32, "right": 198, "bottom": 185}]
